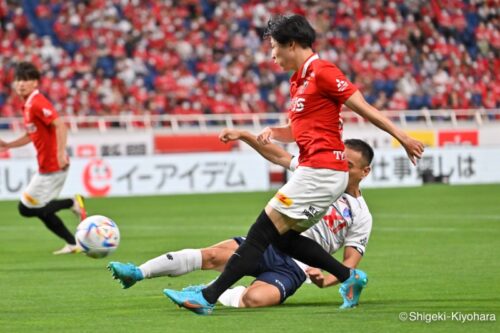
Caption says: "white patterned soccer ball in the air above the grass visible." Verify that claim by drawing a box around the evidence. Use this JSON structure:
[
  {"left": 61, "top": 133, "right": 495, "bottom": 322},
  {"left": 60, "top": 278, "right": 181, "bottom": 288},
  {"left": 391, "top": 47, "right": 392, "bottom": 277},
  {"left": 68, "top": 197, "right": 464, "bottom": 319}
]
[{"left": 75, "top": 215, "right": 120, "bottom": 258}]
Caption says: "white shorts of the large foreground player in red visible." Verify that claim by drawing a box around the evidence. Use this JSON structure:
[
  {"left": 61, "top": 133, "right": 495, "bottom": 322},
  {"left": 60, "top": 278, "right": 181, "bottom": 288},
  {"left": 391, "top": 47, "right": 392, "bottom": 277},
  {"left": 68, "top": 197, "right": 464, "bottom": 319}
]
[{"left": 268, "top": 166, "right": 349, "bottom": 230}]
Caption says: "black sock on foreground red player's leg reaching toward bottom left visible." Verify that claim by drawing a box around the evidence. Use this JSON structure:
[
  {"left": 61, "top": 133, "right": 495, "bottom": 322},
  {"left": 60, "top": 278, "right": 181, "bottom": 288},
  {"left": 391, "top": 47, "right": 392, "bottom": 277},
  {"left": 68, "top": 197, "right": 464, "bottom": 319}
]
[{"left": 202, "top": 211, "right": 279, "bottom": 304}]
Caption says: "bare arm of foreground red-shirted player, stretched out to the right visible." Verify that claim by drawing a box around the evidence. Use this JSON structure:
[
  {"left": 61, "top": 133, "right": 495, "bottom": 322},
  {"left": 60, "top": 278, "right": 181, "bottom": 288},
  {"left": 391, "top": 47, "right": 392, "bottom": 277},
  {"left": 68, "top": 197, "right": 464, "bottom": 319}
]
[{"left": 344, "top": 90, "right": 424, "bottom": 164}]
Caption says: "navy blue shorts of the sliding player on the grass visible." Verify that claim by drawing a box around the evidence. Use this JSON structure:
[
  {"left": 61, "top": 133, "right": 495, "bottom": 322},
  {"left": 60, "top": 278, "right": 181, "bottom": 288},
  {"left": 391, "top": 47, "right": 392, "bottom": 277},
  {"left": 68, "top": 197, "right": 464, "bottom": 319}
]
[{"left": 234, "top": 237, "right": 307, "bottom": 303}]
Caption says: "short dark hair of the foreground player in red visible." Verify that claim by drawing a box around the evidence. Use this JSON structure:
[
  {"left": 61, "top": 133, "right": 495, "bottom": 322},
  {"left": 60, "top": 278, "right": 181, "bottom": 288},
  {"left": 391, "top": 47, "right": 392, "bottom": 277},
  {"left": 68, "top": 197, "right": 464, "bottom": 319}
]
[{"left": 264, "top": 14, "right": 316, "bottom": 48}]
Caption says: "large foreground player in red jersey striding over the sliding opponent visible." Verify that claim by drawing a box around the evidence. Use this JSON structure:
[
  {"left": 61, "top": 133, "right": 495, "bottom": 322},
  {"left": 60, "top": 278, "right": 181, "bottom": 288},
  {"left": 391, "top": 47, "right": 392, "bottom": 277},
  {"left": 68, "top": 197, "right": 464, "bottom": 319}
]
[{"left": 164, "top": 15, "right": 424, "bottom": 314}]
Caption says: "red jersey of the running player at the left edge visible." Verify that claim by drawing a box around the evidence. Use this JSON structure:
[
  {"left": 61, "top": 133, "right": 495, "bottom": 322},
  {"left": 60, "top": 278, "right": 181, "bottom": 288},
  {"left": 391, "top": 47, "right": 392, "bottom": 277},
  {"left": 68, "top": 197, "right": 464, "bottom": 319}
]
[{"left": 23, "top": 90, "right": 61, "bottom": 173}]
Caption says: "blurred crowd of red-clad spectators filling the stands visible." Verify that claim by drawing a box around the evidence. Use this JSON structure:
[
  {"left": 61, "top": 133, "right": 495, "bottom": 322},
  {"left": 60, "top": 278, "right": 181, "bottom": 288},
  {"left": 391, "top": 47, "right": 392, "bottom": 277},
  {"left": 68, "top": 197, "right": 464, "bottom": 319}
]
[{"left": 0, "top": 0, "right": 500, "bottom": 117}]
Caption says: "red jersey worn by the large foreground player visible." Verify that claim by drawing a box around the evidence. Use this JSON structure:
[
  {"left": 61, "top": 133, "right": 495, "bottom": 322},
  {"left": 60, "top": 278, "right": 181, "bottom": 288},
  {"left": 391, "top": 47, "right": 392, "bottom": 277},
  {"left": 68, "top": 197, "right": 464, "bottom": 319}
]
[{"left": 288, "top": 54, "right": 357, "bottom": 171}]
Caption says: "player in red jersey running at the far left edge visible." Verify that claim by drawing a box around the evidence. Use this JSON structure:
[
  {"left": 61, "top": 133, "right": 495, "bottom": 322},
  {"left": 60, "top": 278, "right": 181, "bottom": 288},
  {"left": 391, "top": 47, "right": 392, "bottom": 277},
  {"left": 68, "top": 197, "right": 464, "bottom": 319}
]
[{"left": 0, "top": 62, "right": 86, "bottom": 254}]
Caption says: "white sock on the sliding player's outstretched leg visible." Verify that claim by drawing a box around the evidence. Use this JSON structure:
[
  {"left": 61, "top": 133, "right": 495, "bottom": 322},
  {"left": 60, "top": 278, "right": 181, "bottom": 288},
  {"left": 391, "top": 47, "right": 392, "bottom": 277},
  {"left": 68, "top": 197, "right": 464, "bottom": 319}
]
[{"left": 139, "top": 249, "right": 202, "bottom": 279}]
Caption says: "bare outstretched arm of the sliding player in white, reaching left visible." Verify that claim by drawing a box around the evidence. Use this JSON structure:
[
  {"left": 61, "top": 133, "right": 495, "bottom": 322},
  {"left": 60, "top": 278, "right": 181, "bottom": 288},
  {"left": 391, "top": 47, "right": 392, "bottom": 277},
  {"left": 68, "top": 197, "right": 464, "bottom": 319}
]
[{"left": 219, "top": 128, "right": 292, "bottom": 169}]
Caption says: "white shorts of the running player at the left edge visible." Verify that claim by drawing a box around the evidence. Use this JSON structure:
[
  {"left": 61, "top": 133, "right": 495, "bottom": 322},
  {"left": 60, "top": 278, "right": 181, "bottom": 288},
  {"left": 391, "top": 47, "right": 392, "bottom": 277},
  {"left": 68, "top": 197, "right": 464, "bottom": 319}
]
[{"left": 21, "top": 170, "right": 68, "bottom": 208}]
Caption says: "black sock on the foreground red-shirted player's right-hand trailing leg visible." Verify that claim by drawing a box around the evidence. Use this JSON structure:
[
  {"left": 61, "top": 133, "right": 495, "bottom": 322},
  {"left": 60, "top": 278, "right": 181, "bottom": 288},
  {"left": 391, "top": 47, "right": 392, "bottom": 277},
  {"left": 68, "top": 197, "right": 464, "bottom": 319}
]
[{"left": 273, "top": 230, "right": 351, "bottom": 282}]
